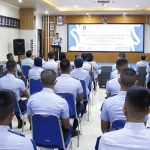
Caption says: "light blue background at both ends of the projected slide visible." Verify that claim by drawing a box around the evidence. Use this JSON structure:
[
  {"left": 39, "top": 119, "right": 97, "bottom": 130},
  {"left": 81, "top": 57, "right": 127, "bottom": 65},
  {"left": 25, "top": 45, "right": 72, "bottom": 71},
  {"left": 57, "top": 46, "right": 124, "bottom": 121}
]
[{"left": 67, "top": 24, "right": 144, "bottom": 52}]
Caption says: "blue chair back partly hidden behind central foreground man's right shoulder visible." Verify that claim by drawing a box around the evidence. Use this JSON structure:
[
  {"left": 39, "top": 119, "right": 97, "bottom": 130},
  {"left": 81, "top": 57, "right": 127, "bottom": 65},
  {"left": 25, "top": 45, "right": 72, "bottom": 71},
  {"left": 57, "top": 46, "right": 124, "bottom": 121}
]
[{"left": 57, "top": 93, "right": 77, "bottom": 118}]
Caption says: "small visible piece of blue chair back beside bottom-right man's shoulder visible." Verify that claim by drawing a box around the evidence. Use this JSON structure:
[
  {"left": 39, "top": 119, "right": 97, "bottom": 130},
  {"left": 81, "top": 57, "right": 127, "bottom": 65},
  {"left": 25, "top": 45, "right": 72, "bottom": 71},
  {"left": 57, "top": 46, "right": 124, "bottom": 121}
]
[{"left": 110, "top": 119, "right": 126, "bottom": 129}]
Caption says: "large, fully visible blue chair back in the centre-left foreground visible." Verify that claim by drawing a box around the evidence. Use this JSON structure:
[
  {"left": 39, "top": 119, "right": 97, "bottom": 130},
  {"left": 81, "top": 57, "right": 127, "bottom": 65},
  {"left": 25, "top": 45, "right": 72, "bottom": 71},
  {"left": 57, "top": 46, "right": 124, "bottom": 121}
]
[{"left": 32, "top": 114, "right": 65, "bottom": 149}]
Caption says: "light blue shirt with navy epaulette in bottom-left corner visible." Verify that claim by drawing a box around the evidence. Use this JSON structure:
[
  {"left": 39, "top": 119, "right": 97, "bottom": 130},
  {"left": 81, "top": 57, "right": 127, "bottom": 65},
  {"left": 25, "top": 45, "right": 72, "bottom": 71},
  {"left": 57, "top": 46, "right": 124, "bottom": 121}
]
[{"left": 0, "top": 125, "right": 34, "bottom": 150}]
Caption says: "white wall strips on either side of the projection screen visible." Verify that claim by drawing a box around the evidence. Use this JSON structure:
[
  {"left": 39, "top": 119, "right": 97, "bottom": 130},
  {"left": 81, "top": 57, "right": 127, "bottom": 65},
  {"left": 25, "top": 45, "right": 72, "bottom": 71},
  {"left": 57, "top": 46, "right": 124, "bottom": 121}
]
[{"left": 56, "top": 24, "right": 150, "bottom": 53}]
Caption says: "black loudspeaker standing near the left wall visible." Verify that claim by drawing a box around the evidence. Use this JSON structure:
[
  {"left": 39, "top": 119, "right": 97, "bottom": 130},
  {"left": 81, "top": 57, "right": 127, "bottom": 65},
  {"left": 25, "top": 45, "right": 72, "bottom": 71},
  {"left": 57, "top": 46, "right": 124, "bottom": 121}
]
[{"left": 13, "top": 39, "right": 25, "bottom": 56}]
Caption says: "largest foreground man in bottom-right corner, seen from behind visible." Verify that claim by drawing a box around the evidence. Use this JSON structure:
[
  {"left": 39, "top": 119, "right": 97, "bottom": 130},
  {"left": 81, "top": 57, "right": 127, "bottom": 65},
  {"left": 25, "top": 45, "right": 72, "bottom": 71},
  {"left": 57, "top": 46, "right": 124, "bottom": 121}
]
[{"left": 98, "top": 86, "right": 150, "bottom": 150}]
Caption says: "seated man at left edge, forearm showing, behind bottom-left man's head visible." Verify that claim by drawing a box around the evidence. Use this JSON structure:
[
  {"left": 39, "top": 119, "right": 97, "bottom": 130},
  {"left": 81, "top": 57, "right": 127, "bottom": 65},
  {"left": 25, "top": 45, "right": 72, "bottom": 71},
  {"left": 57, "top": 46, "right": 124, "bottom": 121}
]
[{"left": 0, "top": 60, "right": 30, "bottom": 128}]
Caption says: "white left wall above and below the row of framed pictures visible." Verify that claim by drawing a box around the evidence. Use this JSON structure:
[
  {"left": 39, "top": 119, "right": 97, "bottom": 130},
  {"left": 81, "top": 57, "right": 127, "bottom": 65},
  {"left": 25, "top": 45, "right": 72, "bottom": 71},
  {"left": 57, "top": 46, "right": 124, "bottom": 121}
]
[{"left": 0, "top": 1, "right": 19, "bottom": 61}]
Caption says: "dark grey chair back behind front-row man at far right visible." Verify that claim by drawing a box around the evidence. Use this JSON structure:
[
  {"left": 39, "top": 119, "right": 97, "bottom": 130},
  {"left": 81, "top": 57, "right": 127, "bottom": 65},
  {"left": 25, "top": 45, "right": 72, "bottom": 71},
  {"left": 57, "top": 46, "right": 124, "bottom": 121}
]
[{"left": 138, "top": 67, "right": 146, "bottom": 86}]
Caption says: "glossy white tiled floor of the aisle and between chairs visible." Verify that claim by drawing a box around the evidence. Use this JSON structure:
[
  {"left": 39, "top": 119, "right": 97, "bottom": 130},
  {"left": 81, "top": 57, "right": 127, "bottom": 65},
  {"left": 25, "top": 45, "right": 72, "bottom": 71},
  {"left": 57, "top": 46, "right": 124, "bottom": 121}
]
[{"left": 13, "top": 88, "right": 150, "bottom": 150}]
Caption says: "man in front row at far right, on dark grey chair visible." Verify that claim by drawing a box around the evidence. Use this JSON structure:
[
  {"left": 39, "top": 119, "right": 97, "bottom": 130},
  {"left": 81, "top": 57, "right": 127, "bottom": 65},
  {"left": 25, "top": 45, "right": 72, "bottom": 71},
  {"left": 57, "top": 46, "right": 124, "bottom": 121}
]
[{"left": 135, "top": 54, "right": 148, "bottom": 73}]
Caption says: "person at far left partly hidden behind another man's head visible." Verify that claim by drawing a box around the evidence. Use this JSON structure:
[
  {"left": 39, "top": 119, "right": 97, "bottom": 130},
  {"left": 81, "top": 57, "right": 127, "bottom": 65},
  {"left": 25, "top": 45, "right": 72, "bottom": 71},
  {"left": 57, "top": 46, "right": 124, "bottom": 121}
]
[{"left": 3, "top": 53, "right": 24, "bottom": 78}]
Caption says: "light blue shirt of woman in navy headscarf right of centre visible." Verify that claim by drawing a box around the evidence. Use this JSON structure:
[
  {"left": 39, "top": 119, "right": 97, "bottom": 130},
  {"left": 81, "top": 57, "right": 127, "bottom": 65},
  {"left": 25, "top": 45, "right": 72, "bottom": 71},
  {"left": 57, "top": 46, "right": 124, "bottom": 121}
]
[{"left": 70, "top": 68, "right": 90, "bottom": 95}]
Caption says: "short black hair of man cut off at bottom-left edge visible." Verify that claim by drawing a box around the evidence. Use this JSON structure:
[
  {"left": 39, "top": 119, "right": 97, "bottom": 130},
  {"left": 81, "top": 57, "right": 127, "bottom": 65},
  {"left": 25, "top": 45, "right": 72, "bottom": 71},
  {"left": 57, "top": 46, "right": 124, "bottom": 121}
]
[{"left": 0, "top": 90, "right": 14, "bottom": 123}]
